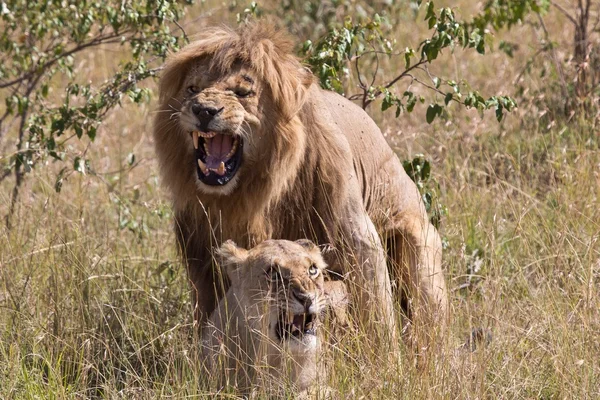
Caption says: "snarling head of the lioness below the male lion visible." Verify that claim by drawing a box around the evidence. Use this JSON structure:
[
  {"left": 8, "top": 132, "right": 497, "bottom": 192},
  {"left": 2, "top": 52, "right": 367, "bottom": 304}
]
[{"left": 219, "top": 240, "right": 326, "bottom": 350}]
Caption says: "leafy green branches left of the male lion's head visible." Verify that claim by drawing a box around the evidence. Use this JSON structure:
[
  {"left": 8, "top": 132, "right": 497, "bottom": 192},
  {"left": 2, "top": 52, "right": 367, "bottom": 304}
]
[{"left": 0, "top": 0, "right": 189, "bottom": 226}]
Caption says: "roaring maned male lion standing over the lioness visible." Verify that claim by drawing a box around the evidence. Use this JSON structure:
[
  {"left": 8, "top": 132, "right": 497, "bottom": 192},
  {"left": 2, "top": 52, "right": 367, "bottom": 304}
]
[{"left": 154, "top": 23, "right": 447, "bottom": 335}]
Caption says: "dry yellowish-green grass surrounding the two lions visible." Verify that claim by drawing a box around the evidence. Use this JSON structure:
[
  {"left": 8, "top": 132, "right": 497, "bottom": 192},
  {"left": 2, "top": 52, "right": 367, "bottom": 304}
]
[{"left": 0, "top": 1, "right": 600, "bottom": 399}]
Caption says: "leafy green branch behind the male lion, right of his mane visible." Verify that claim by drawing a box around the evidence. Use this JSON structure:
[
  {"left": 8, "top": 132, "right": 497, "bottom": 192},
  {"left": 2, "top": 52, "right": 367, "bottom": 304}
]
[{"left": 302, "top": 2, "right": 516, "bottom": 123}]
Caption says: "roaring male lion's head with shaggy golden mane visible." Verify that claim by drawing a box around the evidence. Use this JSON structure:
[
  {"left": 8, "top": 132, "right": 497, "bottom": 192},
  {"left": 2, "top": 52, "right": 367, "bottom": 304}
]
[{"left": 155, "top": 24, "right": 313, "bottom": 195}]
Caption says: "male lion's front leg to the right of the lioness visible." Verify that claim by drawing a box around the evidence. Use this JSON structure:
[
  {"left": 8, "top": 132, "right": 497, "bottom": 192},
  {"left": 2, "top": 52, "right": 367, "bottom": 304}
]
[{"left": 344, "top": 213, "right": 396, "bottom": 343}]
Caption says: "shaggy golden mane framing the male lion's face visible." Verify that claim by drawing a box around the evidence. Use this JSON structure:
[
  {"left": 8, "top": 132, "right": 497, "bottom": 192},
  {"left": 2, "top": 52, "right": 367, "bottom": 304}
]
[{"left": 154, "top": 24, "right": 340, "bottom": 245}]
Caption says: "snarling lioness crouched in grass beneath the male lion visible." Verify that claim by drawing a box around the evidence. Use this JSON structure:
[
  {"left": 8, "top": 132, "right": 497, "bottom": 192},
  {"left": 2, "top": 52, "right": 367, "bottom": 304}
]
[{"left": 202, "top": 240, "right": 343, "bottom": 391}]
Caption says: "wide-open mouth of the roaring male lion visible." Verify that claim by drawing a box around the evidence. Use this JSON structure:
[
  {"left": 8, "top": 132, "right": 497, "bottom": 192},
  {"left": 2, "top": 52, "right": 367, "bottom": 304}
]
[{"left": 191, "top": 131, "right": 243, "bottom": 186}]
